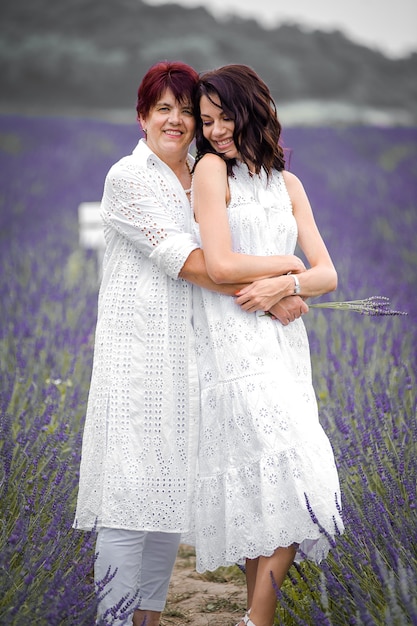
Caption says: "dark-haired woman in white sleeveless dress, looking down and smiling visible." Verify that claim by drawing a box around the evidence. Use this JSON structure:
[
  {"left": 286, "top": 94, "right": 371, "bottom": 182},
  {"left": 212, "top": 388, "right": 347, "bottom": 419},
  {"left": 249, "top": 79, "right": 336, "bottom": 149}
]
[{"left": 192, "top": 65, "right": 343, "bottom": 626}]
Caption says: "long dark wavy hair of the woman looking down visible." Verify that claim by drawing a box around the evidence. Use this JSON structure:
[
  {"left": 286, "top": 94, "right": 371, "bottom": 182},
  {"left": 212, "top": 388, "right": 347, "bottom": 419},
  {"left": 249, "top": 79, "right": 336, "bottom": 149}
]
[{"left": 194, "top": 65, "right": 285, "bottom": 176}]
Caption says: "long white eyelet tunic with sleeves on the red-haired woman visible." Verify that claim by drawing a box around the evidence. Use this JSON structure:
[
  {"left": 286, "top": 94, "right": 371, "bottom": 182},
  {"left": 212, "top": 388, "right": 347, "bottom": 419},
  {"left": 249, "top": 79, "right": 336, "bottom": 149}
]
[{"left": 74, "top": 140, "right": 199, "bottom": 532}]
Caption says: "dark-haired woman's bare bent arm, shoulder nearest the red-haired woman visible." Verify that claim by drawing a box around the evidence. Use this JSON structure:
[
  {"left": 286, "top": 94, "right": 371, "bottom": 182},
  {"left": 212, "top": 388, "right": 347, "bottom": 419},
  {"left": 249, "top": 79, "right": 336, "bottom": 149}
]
[{"left": 193, "top": 154, "right": 305, "bottom": 286}]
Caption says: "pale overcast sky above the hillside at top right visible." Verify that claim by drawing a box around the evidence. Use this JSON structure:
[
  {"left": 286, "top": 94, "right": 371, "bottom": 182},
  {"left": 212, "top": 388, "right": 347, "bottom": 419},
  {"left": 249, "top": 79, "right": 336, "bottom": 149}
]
[{"left": 145, "top": 0, "right": 417, "bottom": 57}]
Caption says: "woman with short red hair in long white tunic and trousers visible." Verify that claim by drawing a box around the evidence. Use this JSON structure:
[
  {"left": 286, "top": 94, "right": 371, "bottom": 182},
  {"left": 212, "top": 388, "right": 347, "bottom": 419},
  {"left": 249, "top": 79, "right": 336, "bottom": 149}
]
[{"left": 74, "top": 61, "right": 238, "bottom": 626}]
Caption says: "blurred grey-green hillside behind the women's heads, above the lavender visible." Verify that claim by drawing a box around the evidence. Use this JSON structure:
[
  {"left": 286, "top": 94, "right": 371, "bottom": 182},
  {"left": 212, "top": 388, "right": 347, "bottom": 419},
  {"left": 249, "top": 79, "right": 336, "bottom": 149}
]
[{"left": 0, "top": 0, "right": 417, "bottom": 125}]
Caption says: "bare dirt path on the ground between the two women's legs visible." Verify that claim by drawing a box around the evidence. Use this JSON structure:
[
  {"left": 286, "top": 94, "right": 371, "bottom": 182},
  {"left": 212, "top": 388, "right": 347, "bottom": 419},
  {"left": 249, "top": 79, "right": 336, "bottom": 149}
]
[{"left": 161, "top": 545, "right": 246, "bottom": 626}]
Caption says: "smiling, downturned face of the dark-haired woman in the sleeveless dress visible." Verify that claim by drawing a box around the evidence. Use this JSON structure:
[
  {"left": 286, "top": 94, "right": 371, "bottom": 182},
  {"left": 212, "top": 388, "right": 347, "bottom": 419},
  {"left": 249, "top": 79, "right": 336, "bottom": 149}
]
[{"left": 200, "top": 94, "right": 239, "bottom": 159}]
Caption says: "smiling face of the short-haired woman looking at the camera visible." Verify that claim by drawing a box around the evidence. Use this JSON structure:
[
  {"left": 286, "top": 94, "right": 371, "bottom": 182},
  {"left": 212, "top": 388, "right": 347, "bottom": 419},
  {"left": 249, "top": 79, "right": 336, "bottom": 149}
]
[{"left": 139, "top": 89, "right": 195, "bottom": 161}]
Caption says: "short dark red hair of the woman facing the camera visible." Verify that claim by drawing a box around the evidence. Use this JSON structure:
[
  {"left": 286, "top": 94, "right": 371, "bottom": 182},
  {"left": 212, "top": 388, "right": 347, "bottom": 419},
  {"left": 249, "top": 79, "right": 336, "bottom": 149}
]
[{"left": 136, "top": 61, "right": 199, "bottom": 117}]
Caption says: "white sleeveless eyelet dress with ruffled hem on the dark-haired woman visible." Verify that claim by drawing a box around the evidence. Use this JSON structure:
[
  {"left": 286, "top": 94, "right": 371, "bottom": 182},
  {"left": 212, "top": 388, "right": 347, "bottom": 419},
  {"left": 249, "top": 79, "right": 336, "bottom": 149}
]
[{"left": 193, "top": 164, "right": 343, "bottom": 572}]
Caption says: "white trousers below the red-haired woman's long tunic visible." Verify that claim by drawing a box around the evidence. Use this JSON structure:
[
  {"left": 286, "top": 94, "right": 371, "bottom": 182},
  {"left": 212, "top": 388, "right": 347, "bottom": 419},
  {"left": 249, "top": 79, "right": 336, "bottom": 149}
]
[{"left": 94, "top": 528, "right": 181, "bottom": 626}]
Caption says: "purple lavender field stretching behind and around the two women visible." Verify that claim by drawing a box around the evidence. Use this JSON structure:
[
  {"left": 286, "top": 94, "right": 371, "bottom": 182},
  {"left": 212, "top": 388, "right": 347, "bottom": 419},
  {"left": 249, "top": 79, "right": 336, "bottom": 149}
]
[{"left": 0, "top": 116, "right": 417, "bottom": 626}]
